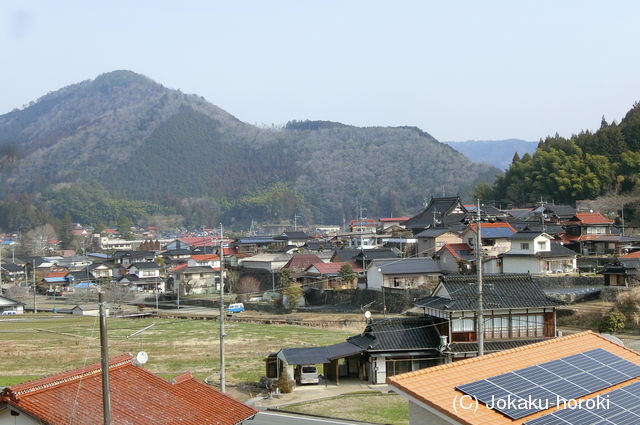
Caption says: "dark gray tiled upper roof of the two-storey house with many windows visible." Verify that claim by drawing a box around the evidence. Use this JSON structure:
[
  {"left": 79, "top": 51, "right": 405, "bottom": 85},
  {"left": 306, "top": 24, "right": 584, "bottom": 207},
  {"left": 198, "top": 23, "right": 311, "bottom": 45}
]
[{"left": 416, "top": 273, "right": 560, "bottom": 311}]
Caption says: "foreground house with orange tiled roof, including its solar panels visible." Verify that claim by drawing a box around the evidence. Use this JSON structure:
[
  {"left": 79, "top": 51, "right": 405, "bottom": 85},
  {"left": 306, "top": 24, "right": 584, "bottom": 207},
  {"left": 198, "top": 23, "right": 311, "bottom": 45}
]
[{"left": 387, "top": 331, "right": 640, "bottom": 425}]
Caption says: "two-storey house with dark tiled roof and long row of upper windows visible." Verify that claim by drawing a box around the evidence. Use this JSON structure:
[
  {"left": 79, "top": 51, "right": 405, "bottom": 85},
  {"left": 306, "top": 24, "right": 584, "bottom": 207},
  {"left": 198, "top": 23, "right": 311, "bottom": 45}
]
[{"left": 415, "top": 274, "right": 559, "bottom": 359}]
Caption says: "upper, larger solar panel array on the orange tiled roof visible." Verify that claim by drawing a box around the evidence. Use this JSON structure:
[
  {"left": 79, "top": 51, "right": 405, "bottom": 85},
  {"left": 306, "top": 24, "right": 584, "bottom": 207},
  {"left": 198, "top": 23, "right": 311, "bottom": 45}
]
[{"left": 456, "top": 348, "right": 640, "bottom": 419}]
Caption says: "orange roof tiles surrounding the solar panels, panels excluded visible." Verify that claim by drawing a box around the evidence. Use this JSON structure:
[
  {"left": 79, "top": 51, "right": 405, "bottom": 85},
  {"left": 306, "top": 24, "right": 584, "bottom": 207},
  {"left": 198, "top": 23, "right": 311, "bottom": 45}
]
[{"left": 387, "top": 331, "right": 640, "bottom": 425}]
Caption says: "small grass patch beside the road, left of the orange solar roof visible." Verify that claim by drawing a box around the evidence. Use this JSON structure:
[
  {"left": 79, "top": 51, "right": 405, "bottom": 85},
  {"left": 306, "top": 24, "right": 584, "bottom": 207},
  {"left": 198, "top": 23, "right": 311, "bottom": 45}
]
[{"left": 281, "top": 392, "right": 409, "bottom": 425}]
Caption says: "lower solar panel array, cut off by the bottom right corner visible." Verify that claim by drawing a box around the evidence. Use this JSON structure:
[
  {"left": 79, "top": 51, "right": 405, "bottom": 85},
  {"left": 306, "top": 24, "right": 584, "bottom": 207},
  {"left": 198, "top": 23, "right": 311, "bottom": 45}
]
[{"left": 525, "top": 382, "right": 640, "bottom": 425}]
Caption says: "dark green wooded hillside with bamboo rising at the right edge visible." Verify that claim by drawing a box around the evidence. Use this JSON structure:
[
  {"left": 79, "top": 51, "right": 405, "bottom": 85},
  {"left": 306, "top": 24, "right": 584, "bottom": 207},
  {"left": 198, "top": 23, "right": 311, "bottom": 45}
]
[{"left": 492, "top": 103, "right": 640, "bottom": 204}]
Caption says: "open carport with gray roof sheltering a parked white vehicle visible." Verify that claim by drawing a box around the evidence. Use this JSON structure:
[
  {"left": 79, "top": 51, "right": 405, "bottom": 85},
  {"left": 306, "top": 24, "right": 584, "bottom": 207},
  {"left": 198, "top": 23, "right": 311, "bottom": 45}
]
[{"left": 276, "top": 342, "right": 367, "bottom": 384}]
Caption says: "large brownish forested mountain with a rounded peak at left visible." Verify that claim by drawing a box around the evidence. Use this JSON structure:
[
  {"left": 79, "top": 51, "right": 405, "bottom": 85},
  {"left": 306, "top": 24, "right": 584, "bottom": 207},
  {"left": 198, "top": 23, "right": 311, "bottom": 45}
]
[{"left": 0, "top": 71, "right": 499, "bottom": 229}]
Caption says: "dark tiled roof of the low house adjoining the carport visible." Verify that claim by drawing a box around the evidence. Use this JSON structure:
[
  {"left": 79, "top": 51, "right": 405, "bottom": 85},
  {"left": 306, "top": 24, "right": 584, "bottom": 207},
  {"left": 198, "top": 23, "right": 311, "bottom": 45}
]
[{"left": 347, "top": 317, "right": 440, "bottom": 352}]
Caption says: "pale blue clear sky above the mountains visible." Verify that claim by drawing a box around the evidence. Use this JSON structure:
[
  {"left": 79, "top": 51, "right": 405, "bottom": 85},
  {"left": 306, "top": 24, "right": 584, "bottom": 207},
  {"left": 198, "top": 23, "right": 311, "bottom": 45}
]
[{"left": 0, "top": 0, "right": 640, "bottom": 141}]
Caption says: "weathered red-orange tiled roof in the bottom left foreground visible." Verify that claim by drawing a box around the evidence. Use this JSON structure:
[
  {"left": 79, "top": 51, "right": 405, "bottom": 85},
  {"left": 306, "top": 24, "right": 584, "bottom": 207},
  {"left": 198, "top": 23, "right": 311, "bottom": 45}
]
[{"left": 0, "top": 354, "right": 257, "bottom": 425}]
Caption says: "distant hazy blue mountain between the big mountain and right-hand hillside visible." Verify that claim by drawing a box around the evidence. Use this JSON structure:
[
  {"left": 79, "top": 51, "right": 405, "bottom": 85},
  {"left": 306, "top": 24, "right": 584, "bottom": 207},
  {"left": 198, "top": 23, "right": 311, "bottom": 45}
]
[{"left": 442, "top": 139, "right": 538, "bottom": 170}]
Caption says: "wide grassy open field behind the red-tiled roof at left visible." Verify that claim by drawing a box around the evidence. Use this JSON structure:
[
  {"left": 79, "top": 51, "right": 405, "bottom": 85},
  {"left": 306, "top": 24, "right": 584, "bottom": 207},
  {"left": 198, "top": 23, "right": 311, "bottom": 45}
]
[{"left": 0, "top": 313, "right": 354, "bottom": 386}]
